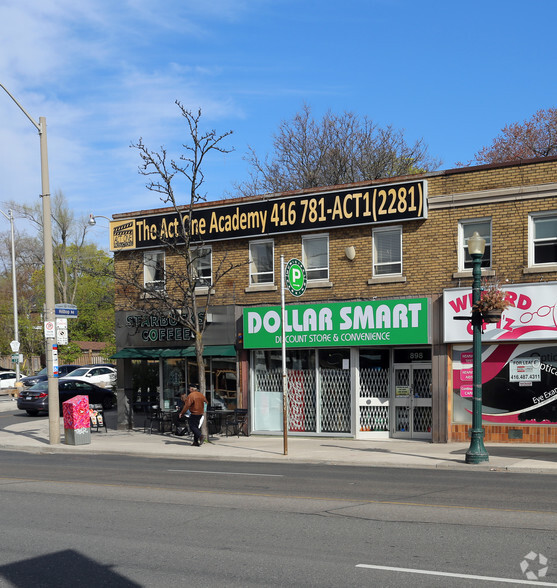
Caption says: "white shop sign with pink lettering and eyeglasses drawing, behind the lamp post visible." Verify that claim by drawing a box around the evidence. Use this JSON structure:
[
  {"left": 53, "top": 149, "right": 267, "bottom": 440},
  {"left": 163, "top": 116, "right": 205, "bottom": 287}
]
[{"left": 443, "top": 282, "right": 557, "bottom": 343}]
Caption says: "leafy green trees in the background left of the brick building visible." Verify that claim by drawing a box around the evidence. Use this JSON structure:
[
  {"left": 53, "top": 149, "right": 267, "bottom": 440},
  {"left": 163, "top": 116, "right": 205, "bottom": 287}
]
[{"left": 0, "top": 192, "right": 114, "bottom": 357}]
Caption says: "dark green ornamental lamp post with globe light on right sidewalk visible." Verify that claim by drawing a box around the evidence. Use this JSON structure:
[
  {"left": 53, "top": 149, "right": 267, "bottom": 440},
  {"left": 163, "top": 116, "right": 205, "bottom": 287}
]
[{"left": 466, "top": 232, "right": 489, "bottom": 464}]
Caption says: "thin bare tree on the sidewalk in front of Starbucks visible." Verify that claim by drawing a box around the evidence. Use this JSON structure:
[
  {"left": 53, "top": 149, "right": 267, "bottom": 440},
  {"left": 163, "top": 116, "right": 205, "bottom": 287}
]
[{"left": 124, "top": 101, "right": 239, "bottom": 412}]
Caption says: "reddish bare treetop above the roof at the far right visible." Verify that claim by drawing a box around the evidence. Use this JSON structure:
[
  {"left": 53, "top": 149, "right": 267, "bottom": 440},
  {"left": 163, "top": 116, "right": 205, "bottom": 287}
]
[{"left": 458, "top": 108, "right": 557, "bottom": 165}]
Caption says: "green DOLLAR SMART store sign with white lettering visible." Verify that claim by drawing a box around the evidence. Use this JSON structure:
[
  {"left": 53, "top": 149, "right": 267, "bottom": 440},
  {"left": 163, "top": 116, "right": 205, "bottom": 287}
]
[{"left": 244, "top": 298, "right": 430, "bottom": 349}]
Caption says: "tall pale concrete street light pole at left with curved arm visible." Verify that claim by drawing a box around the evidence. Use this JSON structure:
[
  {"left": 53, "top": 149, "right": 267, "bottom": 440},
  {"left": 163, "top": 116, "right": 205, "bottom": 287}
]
[{"left": 0, "top": 84, "right": 60, "bottom": 445}]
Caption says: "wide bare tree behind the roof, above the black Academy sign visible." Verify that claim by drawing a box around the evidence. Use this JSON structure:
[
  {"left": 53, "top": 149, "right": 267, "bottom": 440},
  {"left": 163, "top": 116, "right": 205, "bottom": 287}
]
[{"left": 236, "top": 105, "right": 441, "bottom": 196}]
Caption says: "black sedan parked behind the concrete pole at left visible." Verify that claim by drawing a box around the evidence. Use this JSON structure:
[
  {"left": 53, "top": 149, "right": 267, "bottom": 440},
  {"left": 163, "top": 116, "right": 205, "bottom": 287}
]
[{"left": 17, "top": 379, "right": 116, "bottom": 416}]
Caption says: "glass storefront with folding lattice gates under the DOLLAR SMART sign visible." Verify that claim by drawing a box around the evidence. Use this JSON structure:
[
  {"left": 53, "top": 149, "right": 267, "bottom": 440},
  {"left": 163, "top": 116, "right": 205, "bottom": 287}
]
[{"left": 253, "top": 352, "right": 433, "bottom": 439}]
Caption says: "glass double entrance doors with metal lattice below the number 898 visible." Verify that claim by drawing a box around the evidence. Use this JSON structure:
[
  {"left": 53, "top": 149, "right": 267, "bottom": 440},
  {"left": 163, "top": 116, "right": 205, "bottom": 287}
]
[{"left": 391, "top": 363, "right": 433, "bottom": 439}]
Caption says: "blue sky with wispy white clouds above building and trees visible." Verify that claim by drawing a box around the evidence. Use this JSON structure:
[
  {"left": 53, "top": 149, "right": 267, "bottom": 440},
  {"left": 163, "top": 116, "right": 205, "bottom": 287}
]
[{"left": 0, "top": 0, "right": 557, "bottom": 246}]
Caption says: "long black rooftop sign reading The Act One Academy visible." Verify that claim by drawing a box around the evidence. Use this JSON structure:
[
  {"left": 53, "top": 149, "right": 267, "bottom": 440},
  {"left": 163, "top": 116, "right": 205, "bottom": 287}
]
[{"left": 110, "top": 180, "right": 427, "bottom": 251}]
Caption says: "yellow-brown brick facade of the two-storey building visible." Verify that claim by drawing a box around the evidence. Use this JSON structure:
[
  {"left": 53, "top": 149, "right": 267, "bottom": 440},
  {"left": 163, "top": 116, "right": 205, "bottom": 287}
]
[{"left": 115, "top": 158, "right": 557, "bottom": 443}]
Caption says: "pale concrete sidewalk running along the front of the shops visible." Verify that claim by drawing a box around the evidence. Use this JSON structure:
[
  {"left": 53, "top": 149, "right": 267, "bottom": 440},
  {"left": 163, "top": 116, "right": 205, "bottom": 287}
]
[{"left": 0, "top": 396, "right": 557, "bottom": 474}]
